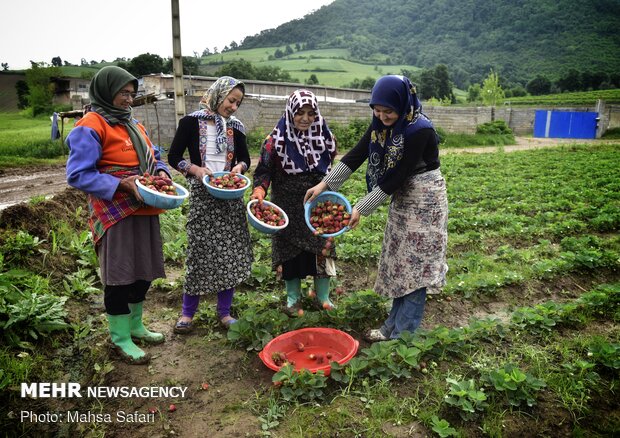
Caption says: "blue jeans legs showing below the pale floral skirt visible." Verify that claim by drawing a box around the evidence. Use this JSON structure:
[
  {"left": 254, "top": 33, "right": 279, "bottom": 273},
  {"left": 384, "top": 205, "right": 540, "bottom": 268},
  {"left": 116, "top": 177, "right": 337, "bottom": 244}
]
[{"left": 380, "top": 287, "right": 426, "bottom": 339}]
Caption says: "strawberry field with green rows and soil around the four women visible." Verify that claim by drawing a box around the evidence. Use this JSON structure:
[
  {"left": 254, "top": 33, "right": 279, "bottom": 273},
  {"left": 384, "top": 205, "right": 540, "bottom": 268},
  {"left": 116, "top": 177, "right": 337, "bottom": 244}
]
[{"left": 0, "top": 144, "right": 620, "bottom": 437}]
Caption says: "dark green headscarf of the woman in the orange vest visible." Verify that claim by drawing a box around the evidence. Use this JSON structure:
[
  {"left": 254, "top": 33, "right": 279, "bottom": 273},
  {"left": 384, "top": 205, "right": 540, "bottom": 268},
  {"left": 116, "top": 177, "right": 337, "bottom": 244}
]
[{"left": 88, "top": 65, "right": 156, "bottom": 174}]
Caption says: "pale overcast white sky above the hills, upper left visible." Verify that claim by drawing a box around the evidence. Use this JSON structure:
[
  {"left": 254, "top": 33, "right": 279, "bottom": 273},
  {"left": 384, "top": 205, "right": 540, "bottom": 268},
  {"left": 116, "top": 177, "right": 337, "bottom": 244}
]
[{"left": 0, "top": 0, "right": 334, "bottom": 70}]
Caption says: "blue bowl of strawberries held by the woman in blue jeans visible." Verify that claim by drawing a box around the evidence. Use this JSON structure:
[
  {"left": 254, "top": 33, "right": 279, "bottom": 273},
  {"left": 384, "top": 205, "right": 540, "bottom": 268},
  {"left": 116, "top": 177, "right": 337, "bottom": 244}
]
[{"left": 304, "top": 192, "right": 352, "bottom": 237}]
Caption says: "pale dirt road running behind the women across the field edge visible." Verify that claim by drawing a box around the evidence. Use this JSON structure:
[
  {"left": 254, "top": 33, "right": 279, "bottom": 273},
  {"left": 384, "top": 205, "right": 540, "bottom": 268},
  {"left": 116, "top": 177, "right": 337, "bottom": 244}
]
[{"left": 0, "top": 137, "right": 600, "bottom": 210}]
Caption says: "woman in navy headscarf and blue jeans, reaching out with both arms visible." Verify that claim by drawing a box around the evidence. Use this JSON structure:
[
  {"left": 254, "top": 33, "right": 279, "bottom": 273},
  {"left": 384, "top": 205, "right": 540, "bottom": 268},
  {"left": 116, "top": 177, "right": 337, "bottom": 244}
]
[{"left": 306, "top": 75, "right": 448, "bottom": 341}]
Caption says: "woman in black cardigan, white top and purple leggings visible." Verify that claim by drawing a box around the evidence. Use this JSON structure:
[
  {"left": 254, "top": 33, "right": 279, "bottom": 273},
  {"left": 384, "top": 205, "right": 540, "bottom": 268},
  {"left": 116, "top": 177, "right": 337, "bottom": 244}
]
[{"left": 168, "top": 76, "right": 253, "bottom": 333}]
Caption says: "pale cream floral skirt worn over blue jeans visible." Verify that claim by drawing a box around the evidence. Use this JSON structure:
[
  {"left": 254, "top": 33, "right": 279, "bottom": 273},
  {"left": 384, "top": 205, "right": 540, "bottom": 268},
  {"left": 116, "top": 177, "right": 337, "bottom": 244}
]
[{"left": 375, "top": 169, "right": 448, "bottom": 298}]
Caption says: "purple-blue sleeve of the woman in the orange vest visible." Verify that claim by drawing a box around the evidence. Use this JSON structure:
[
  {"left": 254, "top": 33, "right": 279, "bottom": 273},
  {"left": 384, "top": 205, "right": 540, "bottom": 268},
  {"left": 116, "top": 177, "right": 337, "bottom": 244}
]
[{"left": 66, "top": 126, "right": 120, "bottom": 200}]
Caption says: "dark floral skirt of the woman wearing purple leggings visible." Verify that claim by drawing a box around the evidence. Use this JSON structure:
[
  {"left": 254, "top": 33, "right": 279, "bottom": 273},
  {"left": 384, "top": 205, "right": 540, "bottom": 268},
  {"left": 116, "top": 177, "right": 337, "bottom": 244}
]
[{"left": 183, "top": 178, "right": 254, "bottom": 295}]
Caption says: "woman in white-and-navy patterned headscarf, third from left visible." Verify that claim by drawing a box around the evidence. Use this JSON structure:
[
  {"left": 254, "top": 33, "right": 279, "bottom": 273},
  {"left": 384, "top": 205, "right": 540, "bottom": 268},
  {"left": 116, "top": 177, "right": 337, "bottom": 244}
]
[{"left": 251, "top": 90, "right": 336, "bottom": 315}]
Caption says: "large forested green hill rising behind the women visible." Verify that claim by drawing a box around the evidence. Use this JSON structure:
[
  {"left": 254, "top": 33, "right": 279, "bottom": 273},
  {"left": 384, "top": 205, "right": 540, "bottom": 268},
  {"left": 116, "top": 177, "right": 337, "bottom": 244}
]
[{"left": 239, "top": 0, "right": 620, "bottom": 88}]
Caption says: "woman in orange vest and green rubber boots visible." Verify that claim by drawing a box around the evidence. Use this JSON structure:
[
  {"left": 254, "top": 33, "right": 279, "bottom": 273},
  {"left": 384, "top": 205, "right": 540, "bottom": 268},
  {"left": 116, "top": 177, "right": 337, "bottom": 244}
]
[{"left": 66, "top": 66, "right": 170, "bottom": 364}]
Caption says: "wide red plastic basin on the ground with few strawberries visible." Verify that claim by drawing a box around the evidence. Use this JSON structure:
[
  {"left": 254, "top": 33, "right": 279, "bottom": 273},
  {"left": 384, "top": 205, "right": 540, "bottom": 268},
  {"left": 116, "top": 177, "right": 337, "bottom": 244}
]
[{"left": 258, "top": 327, "right": 359, "bottom": 376}]
